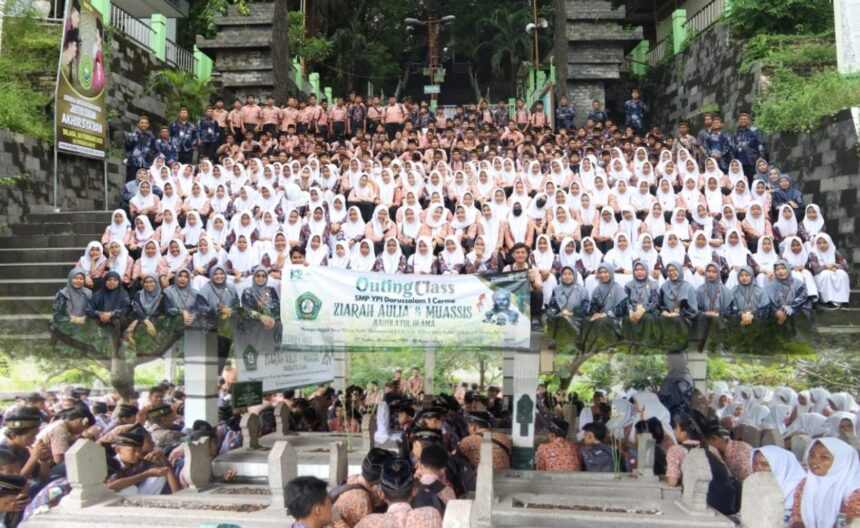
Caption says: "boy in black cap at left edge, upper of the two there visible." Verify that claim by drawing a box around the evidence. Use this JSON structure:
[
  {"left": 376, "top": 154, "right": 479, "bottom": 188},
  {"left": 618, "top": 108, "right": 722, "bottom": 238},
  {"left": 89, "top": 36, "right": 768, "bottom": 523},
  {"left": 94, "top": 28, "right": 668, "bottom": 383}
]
[{"left": 0, "top": 407, "right": 51, "bottom": 478}]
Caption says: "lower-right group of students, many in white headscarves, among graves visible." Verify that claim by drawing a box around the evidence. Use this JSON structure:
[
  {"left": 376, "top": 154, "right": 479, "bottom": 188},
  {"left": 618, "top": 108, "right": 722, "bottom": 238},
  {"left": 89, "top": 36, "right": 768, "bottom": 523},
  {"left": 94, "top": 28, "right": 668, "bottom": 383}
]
[{"left": 536, "top": 382, "right": 860, "bottom": 528}]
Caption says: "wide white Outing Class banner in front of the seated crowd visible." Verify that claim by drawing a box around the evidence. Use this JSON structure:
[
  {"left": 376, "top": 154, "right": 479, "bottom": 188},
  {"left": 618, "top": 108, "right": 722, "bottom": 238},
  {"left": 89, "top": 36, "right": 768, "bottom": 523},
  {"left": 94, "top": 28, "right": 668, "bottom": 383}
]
[{"left": 281, "top": 267, "right": 531, "bottom": 351}]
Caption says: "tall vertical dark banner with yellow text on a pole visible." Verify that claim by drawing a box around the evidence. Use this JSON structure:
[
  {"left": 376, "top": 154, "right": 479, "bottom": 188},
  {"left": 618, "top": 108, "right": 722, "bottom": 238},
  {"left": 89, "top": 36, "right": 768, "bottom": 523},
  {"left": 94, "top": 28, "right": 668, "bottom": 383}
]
[{"left": 55, "top": 0, "right": 107, "bottom": 159}]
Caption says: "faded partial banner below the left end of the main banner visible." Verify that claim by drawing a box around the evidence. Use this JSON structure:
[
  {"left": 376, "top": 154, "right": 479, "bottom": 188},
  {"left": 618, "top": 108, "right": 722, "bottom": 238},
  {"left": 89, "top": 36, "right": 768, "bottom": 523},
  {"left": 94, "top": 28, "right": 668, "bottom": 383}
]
[{"left": 233, "top": 324, "right": 334, "bottom": 393}]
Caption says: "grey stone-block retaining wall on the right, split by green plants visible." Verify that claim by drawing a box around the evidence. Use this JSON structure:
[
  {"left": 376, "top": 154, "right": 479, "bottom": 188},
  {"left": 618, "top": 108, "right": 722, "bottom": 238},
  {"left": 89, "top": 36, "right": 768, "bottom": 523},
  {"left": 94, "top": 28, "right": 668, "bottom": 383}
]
[{"left": 644, "top": 25, "right": 860, "bottom": 271}]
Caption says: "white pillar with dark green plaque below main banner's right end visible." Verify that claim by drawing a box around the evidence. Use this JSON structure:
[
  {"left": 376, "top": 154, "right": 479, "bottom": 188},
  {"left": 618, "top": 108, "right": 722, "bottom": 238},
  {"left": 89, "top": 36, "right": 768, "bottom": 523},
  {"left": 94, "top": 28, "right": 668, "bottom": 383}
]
[{"left": 511, "top": 333, "right": 540, "bottom": 469}]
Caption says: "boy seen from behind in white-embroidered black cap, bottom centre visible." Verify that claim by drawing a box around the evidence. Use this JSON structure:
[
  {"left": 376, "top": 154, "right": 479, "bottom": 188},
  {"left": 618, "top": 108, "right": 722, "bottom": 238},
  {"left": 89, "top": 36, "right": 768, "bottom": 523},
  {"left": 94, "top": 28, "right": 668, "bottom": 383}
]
[{"left": 356, "top": 458, "right": 442, "bottom": 528}]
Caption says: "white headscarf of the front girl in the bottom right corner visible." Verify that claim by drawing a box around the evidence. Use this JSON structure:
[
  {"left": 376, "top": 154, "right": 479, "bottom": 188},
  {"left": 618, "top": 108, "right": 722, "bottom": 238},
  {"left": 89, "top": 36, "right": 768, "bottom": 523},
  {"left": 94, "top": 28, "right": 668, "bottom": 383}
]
[{"left": 800, "top": 438, "right": 860, "bottom": 528}]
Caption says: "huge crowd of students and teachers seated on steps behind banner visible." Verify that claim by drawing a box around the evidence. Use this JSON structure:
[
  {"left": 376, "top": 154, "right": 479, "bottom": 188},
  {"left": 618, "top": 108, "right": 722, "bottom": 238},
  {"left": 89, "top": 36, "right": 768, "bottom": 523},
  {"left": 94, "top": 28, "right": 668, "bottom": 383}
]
[{"left": 63, "top": 94, "right": 850, "bottom": 346}]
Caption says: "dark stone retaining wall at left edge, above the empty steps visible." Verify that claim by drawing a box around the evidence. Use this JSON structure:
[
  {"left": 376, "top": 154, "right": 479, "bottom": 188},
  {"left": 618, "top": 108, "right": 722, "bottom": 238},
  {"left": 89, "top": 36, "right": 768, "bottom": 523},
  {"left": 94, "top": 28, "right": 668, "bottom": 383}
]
[{"left": 0, "top": 130, "right": 125, "bottom": 231}]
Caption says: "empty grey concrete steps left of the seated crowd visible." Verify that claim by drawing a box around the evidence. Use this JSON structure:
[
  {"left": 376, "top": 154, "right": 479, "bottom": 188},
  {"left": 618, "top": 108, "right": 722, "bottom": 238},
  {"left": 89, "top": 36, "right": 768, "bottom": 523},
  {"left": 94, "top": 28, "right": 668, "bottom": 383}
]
[{"left": 0, "top": 211, "right": 110, "bottom": 353}]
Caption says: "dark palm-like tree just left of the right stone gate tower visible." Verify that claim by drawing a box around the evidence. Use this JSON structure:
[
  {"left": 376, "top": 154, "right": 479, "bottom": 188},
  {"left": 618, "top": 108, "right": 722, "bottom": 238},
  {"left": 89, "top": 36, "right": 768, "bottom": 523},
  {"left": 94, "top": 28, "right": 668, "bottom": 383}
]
[{"left": 472, "top": 8, "right": 532, "bottom": 94}]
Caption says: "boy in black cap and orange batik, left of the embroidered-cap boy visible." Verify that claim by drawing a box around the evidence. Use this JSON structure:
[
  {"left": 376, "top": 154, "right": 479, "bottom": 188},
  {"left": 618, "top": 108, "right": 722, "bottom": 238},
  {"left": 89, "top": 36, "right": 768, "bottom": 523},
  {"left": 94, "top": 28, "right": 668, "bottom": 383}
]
[{"left": 329, "top": 447, "right": 394, "bottom": 528}]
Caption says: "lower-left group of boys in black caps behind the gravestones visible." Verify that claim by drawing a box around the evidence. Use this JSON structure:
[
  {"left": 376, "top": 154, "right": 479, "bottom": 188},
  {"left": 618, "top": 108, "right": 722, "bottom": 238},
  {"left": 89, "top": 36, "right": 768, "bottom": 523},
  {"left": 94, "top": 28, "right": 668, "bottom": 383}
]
[{"left": 0, "top": 383, "right": 228, "bottom": 528}]
